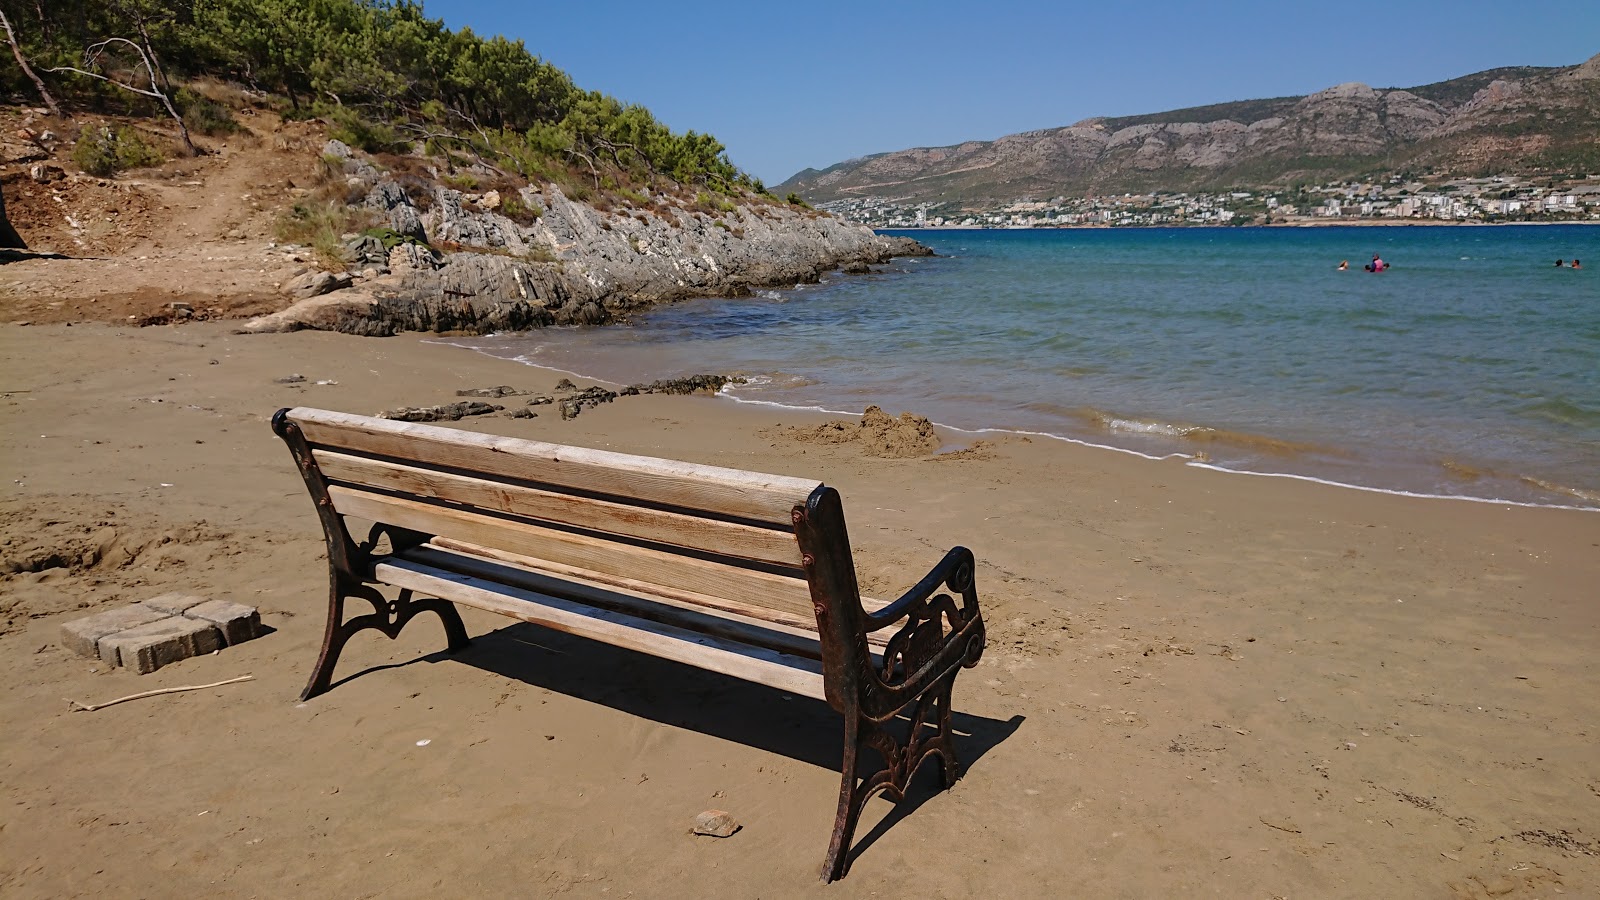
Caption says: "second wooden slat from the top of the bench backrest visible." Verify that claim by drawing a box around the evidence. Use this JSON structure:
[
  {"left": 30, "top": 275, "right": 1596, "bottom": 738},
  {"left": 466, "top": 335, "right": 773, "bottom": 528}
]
[{"left": 312, "top": 450, "right": 800, "bottom": 565}]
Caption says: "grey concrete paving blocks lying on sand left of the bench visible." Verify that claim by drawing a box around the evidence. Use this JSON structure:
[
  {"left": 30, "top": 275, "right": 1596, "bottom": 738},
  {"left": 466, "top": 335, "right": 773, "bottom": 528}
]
[{"left": 61, "top": 594, "right": 261, "bottom": 674}]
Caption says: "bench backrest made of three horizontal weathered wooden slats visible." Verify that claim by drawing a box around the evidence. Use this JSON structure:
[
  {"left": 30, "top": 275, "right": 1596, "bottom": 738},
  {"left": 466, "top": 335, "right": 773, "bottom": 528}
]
[{"left": 275, "top": 407, "right": 848, "bottom": 621}]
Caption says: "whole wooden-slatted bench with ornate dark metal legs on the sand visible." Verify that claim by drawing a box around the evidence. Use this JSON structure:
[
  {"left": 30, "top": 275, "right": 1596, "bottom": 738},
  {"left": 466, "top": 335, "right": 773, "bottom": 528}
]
[{"left": 272, "top": 408, "right": 984, "bottom": 881}]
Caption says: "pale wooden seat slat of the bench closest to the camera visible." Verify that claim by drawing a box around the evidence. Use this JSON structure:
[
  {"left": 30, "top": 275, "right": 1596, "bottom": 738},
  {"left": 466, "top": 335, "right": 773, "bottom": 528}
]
[{"left": 373, "top": 559, "right": 826, "bottom": 700}]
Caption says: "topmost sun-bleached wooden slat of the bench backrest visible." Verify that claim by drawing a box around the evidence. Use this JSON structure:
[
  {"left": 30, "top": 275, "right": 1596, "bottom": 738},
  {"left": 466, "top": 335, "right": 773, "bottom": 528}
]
[{"left": 288, "top": 407, "right": 821, "bottom": 527}]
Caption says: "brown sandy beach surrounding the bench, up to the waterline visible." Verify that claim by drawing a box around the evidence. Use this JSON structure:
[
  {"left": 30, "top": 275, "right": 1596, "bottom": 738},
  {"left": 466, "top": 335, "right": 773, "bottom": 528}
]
[{"left": 0, "top": 323, "right": 1600, "bottom": 900}]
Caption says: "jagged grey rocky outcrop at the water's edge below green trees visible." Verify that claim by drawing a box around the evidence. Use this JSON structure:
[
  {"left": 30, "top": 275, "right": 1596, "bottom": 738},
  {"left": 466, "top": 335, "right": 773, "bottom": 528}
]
[{"left": 245, "top": 141, "right": 930, "bottom": 335}]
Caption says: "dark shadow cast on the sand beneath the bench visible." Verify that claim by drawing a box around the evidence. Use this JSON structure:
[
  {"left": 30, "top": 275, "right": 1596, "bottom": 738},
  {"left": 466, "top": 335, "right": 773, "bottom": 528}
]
[{"left": 333, "top": 623, "right": 1026, "bottom": 858}]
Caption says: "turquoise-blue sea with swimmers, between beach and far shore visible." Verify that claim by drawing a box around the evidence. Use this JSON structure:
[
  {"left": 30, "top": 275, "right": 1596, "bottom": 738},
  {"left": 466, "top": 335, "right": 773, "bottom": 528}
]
[{"left": 454, "top": 226, "right": 1600, "bottom": 509}]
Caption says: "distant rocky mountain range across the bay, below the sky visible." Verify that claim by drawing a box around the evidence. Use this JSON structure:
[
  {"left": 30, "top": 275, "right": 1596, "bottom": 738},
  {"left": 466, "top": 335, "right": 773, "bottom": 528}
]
[{"left": 774, "top": 54, "right": 1600, "bottom": 208}]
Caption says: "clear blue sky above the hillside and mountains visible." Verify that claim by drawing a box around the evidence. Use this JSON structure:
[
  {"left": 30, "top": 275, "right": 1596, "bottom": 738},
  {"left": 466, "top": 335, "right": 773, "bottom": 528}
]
[{"left": 426, "top": 0, "right": 1600, "bottom": 184}]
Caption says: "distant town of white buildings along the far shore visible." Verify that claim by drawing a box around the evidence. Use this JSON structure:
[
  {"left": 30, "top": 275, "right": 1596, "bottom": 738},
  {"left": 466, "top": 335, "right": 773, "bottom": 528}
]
[{"left": 819, "top": 175, "right": 1600, "bottom": 229}]
